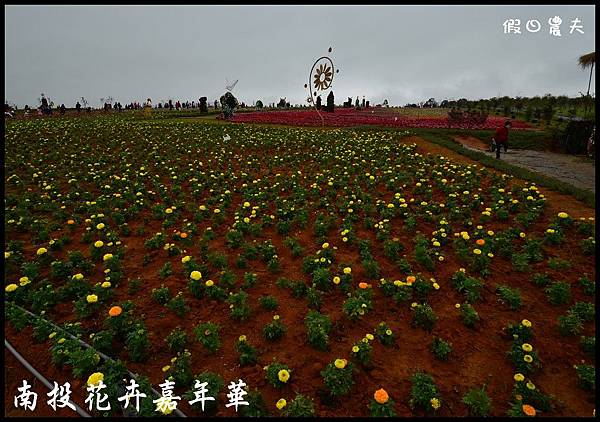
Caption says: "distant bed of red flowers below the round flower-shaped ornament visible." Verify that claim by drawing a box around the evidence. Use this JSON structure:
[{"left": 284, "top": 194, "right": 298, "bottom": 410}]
[{"left": 232, "top": 108, "right": 531, "bottom": 129}]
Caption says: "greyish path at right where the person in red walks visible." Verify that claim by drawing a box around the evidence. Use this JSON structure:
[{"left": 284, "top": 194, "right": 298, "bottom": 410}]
[{"left": 454, "top": 136, "right": 596, "bottom": 193}]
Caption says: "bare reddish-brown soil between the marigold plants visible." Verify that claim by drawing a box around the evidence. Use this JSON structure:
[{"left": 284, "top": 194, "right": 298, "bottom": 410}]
[{"left": 5, "top": 137, "right": 595, "bottom": 416}]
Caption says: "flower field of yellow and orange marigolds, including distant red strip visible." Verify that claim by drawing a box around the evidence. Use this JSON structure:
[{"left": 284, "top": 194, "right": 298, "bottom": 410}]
[{"left": 4, "top": 117, "right": 595, "bottom": 416}]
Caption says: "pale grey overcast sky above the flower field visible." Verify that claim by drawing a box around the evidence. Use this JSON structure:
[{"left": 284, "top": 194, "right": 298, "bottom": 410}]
[{"left": 4, "top": 5, "right": 595, "bottom": 107}]
